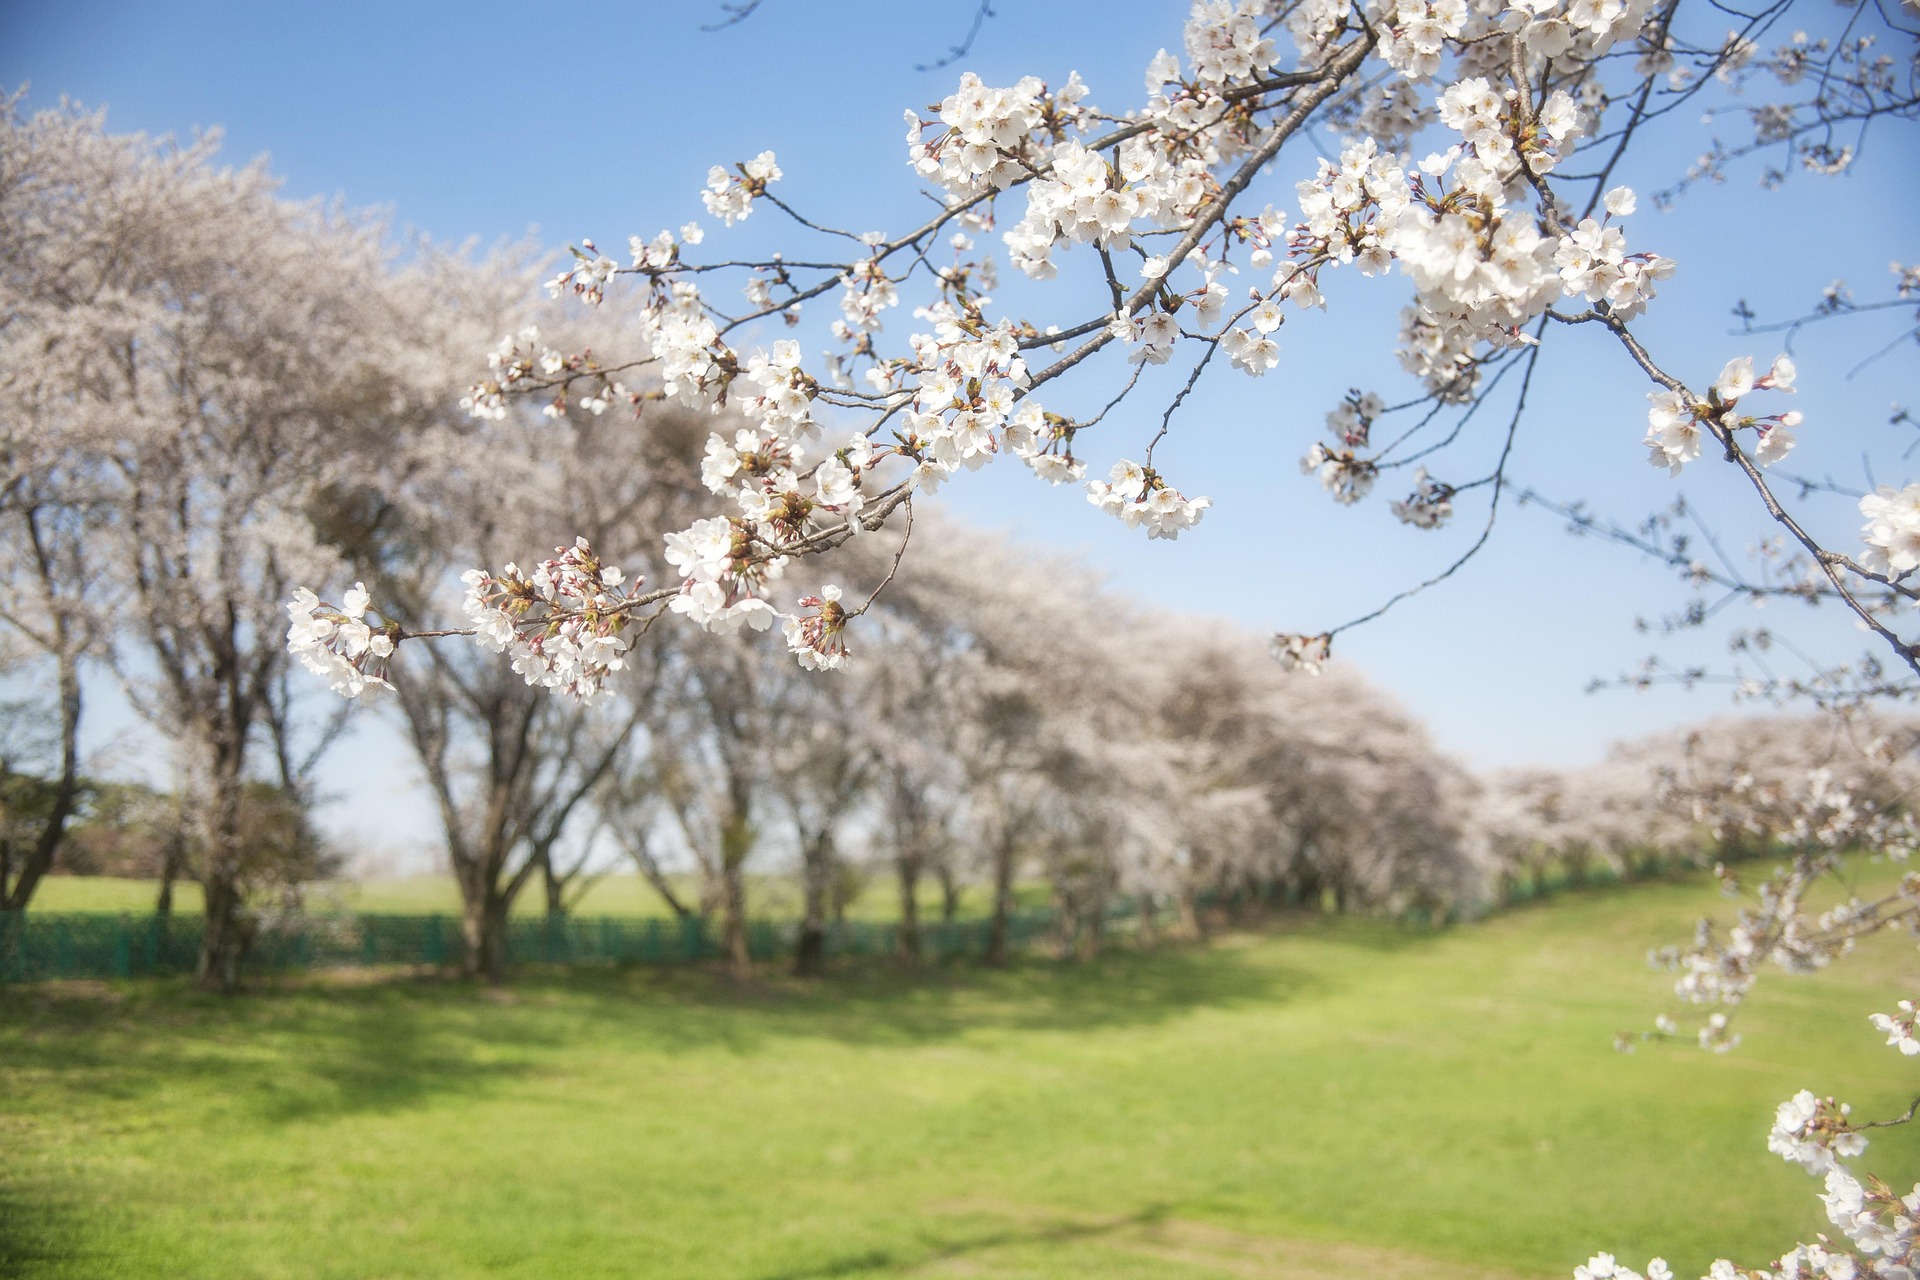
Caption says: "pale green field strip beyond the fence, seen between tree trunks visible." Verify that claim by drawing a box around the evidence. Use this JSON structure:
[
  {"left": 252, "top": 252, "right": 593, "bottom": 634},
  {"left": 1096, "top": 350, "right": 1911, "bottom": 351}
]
[{"left": 18, "top": 875, "right": 1046, "bottom": 919}]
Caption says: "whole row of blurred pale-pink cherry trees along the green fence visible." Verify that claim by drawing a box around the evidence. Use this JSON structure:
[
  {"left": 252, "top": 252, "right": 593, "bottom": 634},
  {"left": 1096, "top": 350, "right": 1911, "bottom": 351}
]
[{"left": 0, "top": 94, "right": 1480, "bottom": 988}]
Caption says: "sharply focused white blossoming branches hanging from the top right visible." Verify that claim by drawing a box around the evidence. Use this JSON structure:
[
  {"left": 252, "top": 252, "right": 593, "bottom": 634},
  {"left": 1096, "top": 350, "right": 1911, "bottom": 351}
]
[{"left": 290, "top": 0, "right": 1920, "bottom": 697}]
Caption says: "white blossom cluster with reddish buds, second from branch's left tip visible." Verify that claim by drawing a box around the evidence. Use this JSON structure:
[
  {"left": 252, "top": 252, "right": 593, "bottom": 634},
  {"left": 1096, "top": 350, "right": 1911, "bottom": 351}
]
[{"left": 461, "top": 537, "right": 639, "bottom": 702}]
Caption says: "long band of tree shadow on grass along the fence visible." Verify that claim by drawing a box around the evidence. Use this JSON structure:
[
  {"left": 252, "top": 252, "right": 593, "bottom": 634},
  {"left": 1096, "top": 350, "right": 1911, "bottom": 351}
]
[{"left": 0, "top": 919, "right": 1436, "bottom": 1123}]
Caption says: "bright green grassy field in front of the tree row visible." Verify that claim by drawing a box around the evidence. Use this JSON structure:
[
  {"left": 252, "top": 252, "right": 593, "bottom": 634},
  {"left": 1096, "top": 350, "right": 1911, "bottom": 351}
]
[{"left": 0, "top": 871, "right": 1920, "bottom": 1280}]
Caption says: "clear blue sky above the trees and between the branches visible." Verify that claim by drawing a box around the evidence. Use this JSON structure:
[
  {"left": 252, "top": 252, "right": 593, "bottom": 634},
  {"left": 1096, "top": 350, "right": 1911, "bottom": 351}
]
[{"left": 0, "top": 0, "right": 1920, "bottom": 871}]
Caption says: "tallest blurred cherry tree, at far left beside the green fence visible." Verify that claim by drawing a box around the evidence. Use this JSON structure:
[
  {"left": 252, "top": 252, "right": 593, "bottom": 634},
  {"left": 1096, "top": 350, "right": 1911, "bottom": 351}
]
[{"left": 0, "top": 100, "right": 456, "bottom": 988}]
